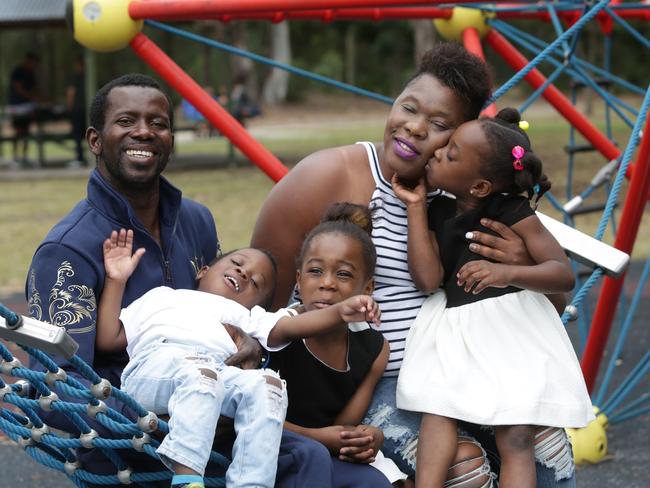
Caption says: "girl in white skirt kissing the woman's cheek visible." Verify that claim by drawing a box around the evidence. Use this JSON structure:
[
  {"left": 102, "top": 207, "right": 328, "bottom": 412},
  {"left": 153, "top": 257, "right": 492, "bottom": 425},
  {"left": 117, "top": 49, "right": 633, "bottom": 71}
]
[{"left": 393, "top": 109, "right": 593, "bottom": 488}]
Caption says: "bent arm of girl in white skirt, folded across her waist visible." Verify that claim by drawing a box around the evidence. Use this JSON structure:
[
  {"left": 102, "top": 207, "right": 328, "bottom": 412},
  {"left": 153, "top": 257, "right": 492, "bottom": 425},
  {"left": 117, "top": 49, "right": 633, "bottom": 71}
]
[{"left": 458, "top": 215, "right": 575, "bottom": 293}]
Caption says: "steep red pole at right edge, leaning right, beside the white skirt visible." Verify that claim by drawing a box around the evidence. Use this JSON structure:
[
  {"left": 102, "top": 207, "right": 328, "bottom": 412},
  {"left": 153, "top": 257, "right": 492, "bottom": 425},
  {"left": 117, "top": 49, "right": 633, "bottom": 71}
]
[{"left": 581, "top": 111, "right": 650, "bottom": 391}]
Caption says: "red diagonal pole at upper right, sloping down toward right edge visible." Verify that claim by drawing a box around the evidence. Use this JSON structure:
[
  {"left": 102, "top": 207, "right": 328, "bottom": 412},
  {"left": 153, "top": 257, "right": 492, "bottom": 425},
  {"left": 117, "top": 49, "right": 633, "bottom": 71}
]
[{"left": 485, "top": 29, "right": 621, "bottom": 161}]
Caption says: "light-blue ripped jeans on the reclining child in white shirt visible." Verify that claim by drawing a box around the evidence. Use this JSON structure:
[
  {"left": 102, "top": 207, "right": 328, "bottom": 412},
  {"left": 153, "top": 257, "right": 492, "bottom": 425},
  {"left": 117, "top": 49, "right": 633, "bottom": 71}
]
[{"left": 122, "top": 342, "right": 287, "bottom": 487}]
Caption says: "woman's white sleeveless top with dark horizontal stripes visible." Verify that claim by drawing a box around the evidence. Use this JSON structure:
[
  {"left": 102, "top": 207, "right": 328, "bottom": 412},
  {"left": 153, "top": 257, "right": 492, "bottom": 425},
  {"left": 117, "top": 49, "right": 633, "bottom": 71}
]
[{"left": 358, "top": 142, "right": 437, "bottom": 376}]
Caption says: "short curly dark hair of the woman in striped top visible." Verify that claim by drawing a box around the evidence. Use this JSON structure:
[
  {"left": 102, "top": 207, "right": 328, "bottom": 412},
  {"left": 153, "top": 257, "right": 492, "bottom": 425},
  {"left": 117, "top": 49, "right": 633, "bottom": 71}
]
[{"left": 406, "top": 42, "right": 492, "bottom": 120}]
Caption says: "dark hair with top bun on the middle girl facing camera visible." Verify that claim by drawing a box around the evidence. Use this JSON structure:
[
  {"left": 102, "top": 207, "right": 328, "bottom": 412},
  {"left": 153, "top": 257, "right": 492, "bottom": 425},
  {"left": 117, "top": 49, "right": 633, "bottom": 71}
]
[{"left": 296, "top": 202, "right": 377, "bottom": 278}]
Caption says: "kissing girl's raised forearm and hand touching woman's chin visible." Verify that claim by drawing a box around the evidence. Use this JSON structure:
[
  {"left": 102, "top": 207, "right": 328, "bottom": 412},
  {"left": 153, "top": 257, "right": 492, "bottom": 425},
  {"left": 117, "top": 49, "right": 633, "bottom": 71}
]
[{"left": 391, "top": 175, "right": 444, "bottom": 293}]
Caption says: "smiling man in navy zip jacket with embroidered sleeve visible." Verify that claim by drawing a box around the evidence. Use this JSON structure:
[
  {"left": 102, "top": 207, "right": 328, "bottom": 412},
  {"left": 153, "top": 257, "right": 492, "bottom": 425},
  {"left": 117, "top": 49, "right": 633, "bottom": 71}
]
[{"left": 26, "top": 74, "right": 321, "bottom": 486}]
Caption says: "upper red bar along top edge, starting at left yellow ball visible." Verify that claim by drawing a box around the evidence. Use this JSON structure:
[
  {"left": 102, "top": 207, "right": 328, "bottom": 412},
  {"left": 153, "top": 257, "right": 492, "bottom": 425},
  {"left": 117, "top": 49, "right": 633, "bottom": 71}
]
[{"left": 129, "top": 0, "right": 483, "bottom": 20}]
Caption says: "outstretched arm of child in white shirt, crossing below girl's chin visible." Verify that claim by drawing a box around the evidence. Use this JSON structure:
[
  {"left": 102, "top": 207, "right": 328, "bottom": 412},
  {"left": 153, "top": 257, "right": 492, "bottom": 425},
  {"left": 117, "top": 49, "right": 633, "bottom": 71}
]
[{"left": 267, "top": 295, "right": 381, "bottom": 347}]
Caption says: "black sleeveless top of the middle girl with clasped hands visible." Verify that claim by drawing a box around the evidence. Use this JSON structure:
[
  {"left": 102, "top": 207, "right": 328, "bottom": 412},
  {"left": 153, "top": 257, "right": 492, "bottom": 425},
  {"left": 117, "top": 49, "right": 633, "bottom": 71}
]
[{"left": 269, "top": 324, "right": 384, "bottom": 428}]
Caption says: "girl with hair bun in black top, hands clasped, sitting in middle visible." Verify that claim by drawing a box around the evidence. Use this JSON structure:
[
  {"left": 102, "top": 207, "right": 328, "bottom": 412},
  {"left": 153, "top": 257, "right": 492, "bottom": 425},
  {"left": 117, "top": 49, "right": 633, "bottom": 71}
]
[{"left": 270, "top": 203, "right": 400, "bottom": 488}]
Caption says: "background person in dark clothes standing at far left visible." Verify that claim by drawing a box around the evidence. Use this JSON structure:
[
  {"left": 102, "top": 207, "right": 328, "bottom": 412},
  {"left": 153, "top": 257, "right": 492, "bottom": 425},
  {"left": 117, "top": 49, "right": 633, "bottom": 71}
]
[{"left": 8, "top": 52, "right": 39, "bottom": 162}]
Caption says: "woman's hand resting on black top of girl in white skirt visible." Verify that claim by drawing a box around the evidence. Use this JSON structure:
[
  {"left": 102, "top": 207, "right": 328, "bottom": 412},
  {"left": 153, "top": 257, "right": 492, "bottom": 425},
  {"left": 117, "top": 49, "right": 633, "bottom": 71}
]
[{"left": 466, "top": 219, "right": 535, "bottom": 266}]
